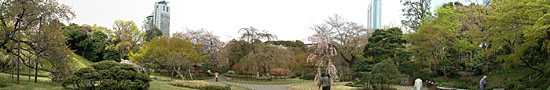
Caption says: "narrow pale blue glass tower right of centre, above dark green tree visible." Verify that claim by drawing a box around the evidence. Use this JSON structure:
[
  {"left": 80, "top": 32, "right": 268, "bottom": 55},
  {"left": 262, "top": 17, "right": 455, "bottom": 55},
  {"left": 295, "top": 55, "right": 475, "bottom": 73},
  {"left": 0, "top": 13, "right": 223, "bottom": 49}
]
[{"left": 367, "top": 0, "right": 382, "bottom": 29}]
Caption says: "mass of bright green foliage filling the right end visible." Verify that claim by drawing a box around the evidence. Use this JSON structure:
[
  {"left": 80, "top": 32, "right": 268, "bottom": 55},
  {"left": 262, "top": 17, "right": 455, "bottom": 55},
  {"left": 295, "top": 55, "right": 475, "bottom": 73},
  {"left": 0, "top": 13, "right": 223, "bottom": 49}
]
[{"left": 405, "top": 0, "right": 550, "bottom": 89}]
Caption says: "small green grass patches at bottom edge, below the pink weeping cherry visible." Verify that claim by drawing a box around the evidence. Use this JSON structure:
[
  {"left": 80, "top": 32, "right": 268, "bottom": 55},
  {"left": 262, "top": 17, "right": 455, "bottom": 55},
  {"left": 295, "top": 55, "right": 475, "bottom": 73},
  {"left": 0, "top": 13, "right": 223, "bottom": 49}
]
[{"left": 289, "top": 82, "right": 361, "bottom": 90}]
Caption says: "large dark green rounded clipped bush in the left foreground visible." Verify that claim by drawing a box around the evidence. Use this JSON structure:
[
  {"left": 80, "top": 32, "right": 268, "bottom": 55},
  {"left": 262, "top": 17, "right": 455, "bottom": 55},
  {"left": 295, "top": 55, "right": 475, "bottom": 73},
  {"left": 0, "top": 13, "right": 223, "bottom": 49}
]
[{"left": 61, "top": 61, "right": 151, "bottom": 90}]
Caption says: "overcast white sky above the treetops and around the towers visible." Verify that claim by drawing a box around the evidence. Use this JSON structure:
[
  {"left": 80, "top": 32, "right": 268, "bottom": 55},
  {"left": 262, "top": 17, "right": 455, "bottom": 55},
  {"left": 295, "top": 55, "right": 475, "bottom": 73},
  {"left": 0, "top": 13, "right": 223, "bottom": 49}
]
[{"left": 60, "top": 0, "right": 476, "bottom": 42}]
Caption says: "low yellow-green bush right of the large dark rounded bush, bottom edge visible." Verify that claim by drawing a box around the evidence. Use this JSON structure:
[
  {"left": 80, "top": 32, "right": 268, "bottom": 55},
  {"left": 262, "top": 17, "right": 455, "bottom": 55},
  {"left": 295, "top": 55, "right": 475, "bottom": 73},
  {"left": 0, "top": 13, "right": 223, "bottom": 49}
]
[{"left": 170, "top": 80, "right": 210, "bottom": 89}]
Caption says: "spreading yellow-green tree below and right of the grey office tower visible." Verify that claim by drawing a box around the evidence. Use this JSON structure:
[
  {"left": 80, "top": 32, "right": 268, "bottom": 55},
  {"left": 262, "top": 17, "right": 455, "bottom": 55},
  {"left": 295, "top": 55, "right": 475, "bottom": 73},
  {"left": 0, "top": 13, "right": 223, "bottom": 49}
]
[{"left": 129, "top": 37, "right": 206, "bottom": 80}]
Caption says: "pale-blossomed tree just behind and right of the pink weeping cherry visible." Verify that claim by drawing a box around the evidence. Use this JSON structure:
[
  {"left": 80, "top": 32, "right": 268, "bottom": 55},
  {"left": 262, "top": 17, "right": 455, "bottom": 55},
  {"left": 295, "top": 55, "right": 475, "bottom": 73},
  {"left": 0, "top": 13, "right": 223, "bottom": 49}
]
[{"left": 312, "top": 15, "right": 372, "bottom": 79}]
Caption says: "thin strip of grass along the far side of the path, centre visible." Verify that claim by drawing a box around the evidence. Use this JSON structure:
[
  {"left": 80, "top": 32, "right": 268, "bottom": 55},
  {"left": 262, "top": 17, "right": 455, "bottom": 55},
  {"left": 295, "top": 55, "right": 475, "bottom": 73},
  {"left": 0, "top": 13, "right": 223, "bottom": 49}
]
[{"left": 228, "top": 78, "right": 313, "bottom": 84}]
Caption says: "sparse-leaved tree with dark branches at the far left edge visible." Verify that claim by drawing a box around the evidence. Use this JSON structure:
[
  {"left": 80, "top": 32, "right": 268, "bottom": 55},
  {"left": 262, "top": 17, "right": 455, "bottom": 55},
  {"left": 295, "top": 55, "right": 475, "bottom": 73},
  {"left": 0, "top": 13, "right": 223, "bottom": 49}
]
[{"left": 0, "top": 0, "right": 74, "bottom": 82}]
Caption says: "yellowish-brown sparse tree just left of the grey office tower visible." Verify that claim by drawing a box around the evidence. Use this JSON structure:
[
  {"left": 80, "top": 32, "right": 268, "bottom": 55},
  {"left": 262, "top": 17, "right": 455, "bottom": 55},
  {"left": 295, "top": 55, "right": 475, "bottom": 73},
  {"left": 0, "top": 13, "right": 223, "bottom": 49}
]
[{"left": 108, "top": 20, "right": 144, "bottom": 59}]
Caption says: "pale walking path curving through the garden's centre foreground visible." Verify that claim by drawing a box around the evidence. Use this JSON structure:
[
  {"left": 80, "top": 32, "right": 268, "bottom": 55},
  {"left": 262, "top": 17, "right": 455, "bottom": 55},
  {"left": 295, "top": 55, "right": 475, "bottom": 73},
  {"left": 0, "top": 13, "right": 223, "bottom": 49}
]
[{"left": 204, "top": 76, "right": 308, "bottom": 90}]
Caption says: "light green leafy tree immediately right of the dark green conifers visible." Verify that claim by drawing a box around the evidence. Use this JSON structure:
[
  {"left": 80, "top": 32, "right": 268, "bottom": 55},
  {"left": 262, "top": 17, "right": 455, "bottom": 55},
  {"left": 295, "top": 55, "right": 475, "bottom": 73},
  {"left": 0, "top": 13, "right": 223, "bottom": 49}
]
[{"left": 405, "top": 7, "right": 466, "bottom": 77}]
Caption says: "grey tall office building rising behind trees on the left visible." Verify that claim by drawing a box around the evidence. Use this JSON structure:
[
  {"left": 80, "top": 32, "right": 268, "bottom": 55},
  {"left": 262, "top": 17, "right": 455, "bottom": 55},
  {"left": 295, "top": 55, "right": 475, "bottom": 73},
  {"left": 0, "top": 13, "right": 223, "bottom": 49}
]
[{"left": 145, "top": 1, "right": 170, "bottom": 35}]
